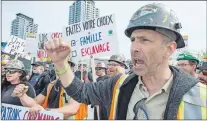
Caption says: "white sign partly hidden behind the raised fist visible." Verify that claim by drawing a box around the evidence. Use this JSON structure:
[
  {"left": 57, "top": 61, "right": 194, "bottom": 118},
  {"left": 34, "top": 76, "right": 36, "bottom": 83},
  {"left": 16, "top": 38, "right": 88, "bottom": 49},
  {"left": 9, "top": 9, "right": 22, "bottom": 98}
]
[{"left": 36, "top": 32, "right": 62, "bottom": 61}]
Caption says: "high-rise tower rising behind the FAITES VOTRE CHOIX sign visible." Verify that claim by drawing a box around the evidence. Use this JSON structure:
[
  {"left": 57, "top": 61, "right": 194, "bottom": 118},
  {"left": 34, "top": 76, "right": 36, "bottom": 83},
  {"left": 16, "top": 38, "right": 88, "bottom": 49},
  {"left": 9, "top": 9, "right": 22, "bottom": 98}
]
[{"left": 68, "top": 0, "right": 99, "bottom": 25}]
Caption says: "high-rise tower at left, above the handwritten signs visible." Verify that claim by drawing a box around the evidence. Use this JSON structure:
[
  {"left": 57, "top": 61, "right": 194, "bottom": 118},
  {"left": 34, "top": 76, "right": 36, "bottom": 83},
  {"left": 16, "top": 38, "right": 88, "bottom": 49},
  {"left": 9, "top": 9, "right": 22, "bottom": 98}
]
[{"left": 11, "top": 13, "right": 38, "bottom": 39}]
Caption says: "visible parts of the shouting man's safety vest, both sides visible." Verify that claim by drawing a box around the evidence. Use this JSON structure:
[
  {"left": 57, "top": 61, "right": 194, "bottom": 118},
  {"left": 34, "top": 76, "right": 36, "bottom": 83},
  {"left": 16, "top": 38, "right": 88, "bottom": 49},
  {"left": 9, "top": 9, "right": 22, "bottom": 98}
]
[{"left": 109, "top": 75, "right": 207, "bottom": 120}]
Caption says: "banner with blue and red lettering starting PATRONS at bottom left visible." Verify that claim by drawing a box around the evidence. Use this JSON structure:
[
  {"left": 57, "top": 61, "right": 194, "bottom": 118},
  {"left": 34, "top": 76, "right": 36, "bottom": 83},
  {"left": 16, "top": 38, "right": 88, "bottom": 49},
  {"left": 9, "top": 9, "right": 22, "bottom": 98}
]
[{"left": 1, "top": 103, "right": 63, "bottom": 120}]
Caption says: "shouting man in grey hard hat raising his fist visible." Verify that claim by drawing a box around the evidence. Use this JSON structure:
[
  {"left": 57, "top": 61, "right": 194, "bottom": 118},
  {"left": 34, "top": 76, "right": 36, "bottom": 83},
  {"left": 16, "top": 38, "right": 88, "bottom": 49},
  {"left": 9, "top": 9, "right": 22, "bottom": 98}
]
[{"left": 21, "top": 3, "right": 207, "bottom": 120}]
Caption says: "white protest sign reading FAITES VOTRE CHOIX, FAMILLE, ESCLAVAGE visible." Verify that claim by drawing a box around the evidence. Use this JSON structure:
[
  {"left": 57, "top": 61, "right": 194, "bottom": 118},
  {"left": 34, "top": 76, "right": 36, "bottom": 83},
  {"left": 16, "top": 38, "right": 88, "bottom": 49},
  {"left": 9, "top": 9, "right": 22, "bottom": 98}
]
[{"left": 63, "top": 14, "right": 119, "bottom": 63}]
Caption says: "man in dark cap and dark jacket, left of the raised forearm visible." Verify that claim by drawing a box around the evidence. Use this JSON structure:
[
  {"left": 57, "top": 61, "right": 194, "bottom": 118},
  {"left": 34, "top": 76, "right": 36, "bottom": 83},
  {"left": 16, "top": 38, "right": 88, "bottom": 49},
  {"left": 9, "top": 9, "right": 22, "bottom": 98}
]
[{"left": 29, "top": 62, "right": 51, "bottom": 95}]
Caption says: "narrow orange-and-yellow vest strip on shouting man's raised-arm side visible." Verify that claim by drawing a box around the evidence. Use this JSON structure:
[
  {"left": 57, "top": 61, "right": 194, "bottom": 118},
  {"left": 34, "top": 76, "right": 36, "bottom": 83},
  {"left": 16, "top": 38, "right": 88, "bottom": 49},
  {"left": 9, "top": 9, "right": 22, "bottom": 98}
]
[{"left": 109, "top": 75, "right": 128, "bottom": 120}]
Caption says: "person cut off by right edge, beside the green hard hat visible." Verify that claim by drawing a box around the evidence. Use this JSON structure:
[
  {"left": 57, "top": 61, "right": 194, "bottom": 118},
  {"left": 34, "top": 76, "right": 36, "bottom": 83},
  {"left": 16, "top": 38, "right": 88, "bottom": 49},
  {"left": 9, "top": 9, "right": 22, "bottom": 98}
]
[{"left": 197, "top": 57, "right": 207, "bottom": 85}]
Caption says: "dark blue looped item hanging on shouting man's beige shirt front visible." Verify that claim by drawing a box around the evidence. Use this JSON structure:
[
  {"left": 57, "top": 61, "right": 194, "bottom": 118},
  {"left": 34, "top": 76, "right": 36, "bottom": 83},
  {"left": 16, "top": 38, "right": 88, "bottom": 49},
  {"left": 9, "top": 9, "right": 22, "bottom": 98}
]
[{"left": 133, "top": 98, "right": 149, "bottom": 120}]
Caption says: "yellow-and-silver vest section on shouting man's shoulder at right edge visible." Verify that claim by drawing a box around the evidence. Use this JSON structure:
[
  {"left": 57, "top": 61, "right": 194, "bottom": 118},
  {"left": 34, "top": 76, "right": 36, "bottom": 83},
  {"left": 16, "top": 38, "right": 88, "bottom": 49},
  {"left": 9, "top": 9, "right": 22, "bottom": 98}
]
[{"left": 177, "top": 83, "right": 207, "bottom": 120}]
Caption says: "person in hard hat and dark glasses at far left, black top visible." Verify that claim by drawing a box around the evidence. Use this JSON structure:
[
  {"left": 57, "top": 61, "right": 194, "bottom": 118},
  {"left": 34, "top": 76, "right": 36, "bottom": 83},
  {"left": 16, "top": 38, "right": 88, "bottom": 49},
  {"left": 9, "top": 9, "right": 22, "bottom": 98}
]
[{"left": 1, "top": 60, "right": 36, "bottom": 106}]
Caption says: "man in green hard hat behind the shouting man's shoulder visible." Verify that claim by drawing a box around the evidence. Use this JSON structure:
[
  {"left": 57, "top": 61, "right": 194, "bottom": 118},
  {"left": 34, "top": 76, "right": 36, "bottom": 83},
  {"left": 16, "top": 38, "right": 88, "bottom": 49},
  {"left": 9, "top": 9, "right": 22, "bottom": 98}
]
[{"left": 177, "top": 53, "right": 199, "bottom": 78}]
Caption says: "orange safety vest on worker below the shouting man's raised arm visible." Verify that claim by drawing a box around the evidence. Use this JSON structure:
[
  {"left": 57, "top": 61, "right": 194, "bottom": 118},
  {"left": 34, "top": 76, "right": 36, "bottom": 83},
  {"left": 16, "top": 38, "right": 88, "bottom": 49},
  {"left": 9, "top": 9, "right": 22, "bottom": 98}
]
[{"left": 42, "top": 81, "right": 88, "bottom": 120}]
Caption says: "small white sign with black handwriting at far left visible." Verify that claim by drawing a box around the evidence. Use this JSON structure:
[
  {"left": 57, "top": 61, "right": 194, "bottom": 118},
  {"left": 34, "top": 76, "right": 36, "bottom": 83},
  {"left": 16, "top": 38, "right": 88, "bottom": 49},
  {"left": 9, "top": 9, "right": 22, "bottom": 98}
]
[{"left": 4, "top": 35, "right": 25, "bottom": 55}]
